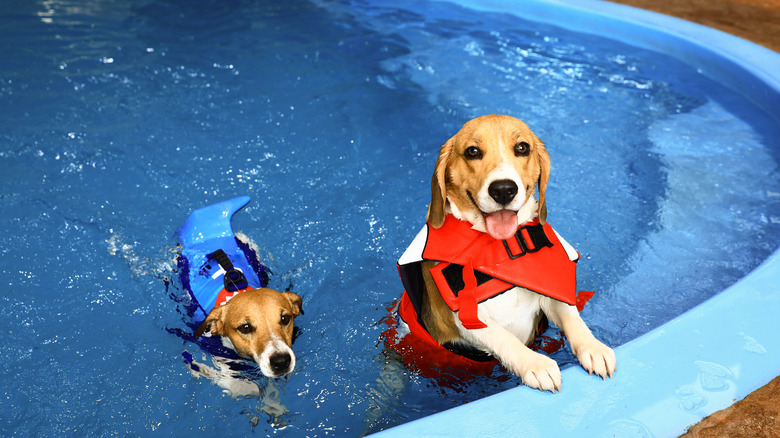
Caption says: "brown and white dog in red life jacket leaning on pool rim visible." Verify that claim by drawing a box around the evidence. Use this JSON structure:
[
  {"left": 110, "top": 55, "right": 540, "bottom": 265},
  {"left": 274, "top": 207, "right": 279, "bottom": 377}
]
[{"left": 399, "top": 115, "right": 616, "bottom": 392}]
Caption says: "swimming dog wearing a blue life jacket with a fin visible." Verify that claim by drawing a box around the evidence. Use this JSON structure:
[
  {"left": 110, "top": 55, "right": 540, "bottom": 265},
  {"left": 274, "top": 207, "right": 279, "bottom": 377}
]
[{"left": 176, "top": 196, "right": 303, "bottom": 418}]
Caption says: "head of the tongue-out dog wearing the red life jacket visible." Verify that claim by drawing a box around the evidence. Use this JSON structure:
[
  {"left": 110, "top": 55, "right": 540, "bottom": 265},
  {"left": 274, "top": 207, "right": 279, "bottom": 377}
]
[{"left": 428, "top": 115, "right": 550, "bottom": 240}]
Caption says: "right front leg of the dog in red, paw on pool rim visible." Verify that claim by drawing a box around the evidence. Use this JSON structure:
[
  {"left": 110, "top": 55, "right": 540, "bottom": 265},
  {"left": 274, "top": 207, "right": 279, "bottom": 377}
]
[{"left": 542, "top": 298, "right": 616, "bottom": 380}]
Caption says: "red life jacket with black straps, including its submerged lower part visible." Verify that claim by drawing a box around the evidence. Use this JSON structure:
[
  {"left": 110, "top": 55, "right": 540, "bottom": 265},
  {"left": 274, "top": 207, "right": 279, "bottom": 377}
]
[{"left": 384, "top": 215, "right": 593, "bottom": 374}]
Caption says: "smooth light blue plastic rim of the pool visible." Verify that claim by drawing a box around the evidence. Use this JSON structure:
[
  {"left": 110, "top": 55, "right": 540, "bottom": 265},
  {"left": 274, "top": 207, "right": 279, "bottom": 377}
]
[{"left": 378, "top": 0, "right": 780, "bottom": 437}]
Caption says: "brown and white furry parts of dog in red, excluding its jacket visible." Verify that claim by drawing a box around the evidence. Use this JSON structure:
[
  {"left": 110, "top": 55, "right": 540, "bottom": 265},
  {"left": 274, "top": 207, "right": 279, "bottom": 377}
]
[{"left": 421, "top": 115, "right": 616, "bottom": 392}]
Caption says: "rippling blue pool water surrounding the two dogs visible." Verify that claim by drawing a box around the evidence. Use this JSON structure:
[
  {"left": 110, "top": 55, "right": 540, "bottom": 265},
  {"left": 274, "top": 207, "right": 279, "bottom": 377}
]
[{"left": 0, "top": 0, "right": 780, "bottom": 436}]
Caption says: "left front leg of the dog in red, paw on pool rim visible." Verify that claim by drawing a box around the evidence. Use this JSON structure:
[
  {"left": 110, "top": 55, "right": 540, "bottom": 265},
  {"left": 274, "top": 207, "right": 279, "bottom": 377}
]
[{"left": 463, "top": 312, "right": 562, "bottom": 392}]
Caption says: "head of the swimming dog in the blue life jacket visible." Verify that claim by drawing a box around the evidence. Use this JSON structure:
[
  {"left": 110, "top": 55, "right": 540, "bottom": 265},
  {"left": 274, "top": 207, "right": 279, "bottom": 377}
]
[{"left": 195, "top": 288, "right": 303, "bottom": 377}]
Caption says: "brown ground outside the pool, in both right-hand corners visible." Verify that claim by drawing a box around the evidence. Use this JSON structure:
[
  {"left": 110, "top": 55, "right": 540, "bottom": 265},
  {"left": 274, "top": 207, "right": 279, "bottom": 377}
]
[{"left": 611, "top": 0, "right": 780, "bottom": 438}]
